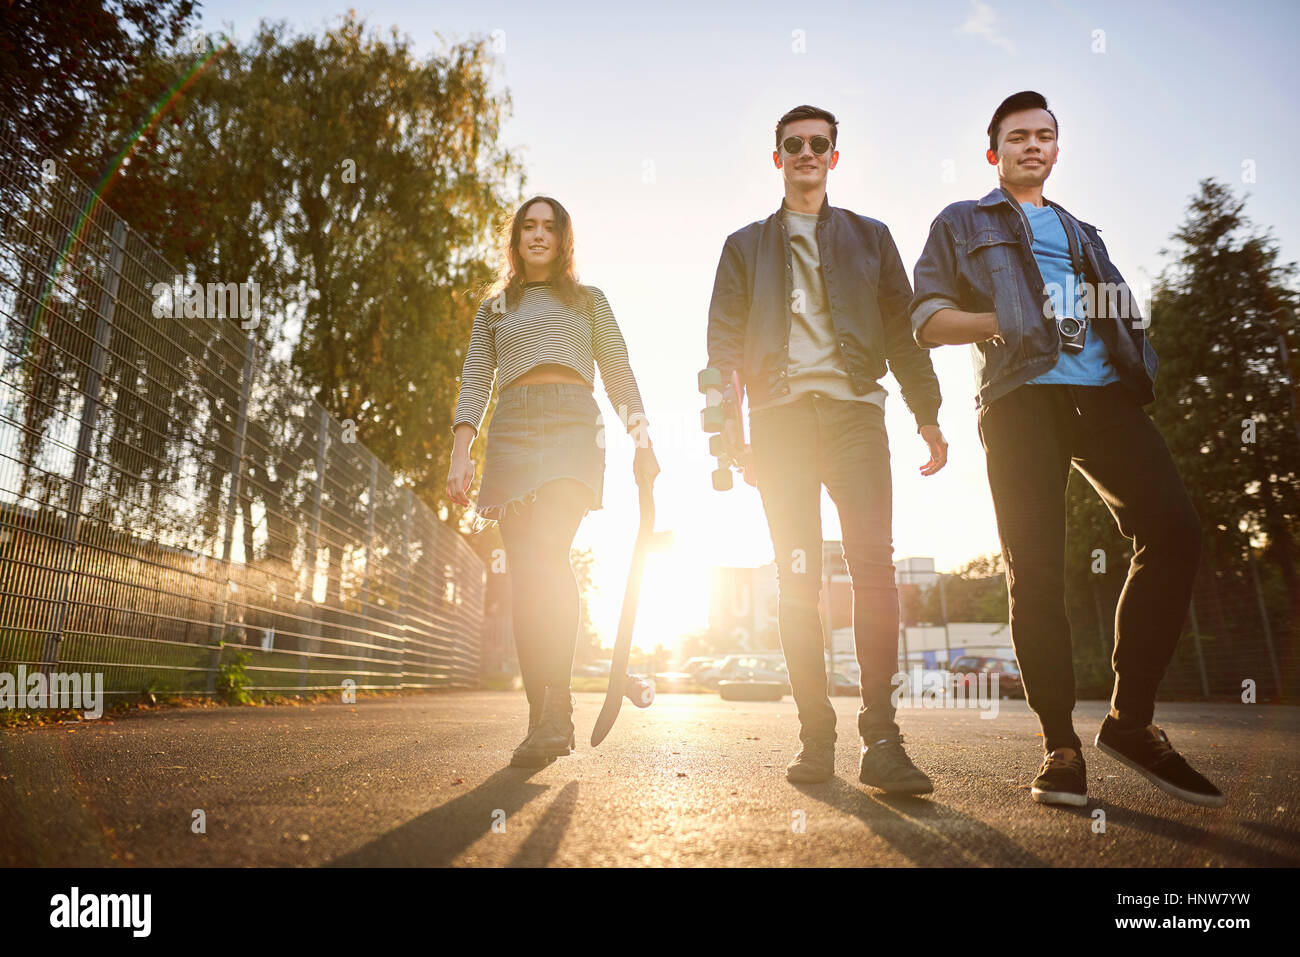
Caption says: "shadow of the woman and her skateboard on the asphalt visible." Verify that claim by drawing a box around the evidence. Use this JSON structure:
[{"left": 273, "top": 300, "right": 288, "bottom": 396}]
[{"left": 325, "top": 767, "right": 556, "bottom": 867}]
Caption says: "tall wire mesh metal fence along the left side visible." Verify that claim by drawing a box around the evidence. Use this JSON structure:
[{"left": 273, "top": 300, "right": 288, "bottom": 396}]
[{"left": 0, "top": 111, "right": 486, "bottom": 696}]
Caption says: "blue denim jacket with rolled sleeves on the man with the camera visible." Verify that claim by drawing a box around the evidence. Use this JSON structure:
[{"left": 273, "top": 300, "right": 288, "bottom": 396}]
[{"left": 911, "top": 189, "right": 1160, "bottom": 408}]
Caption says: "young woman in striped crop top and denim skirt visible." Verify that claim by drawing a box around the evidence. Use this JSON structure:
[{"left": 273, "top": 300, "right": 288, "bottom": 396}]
[{"left": 447, "top": 196, "right": 659, "bottom": 767}]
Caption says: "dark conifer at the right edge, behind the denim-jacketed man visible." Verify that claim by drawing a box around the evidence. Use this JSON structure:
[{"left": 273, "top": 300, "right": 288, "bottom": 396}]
[{"left": 1151, "top": 179, "right": 1300, "bottom": 622}]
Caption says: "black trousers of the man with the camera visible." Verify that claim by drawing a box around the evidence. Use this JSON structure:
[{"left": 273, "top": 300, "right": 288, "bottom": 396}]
[{"left": 979, "top": 382, "right": 1201, "bottom": 752}]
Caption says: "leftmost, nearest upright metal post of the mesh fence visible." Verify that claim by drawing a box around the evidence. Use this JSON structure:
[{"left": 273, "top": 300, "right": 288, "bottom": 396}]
[{"left": 40, "top": 220, "right": 126, "bottom": 675}]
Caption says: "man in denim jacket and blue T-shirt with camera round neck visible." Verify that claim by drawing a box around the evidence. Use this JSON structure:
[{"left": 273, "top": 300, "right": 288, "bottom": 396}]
[{"left": 911, "top": 91, "right": 1226, "bottom": 807}]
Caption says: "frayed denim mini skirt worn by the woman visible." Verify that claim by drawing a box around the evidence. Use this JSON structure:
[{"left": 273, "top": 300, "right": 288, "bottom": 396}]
[{"left": 473, "top": 382, "right": 605, "bottom": 532}]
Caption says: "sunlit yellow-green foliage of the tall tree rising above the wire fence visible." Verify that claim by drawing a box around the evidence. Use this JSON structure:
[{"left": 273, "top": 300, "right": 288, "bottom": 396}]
[{"left": 82, "top": 13, "right": 523, "bottom": 538}]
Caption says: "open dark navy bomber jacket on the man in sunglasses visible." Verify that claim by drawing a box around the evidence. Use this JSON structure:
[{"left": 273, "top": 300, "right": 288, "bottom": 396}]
[{"left": 709, "top": 199, "right": 941, "bottom": 430}]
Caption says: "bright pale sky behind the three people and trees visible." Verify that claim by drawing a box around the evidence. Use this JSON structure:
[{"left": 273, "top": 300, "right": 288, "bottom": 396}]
[{"left": 200, "top": 0, "right": 1300, "bottom": 648}]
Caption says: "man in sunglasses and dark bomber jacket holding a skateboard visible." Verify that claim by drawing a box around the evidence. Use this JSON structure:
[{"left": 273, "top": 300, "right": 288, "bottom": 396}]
[{"left": 709, "top": 105, "right": 948, "bottom": 794}]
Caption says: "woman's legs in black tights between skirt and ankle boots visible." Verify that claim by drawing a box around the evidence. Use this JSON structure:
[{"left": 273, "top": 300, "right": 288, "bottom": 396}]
[{"left": 501, "top": 479, "right": 592, "bottom": 720}]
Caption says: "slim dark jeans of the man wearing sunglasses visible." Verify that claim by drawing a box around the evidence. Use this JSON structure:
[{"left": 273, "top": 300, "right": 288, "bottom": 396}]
[{"left": 750, "top": 393, "right": 898, "bottom": 741}]
